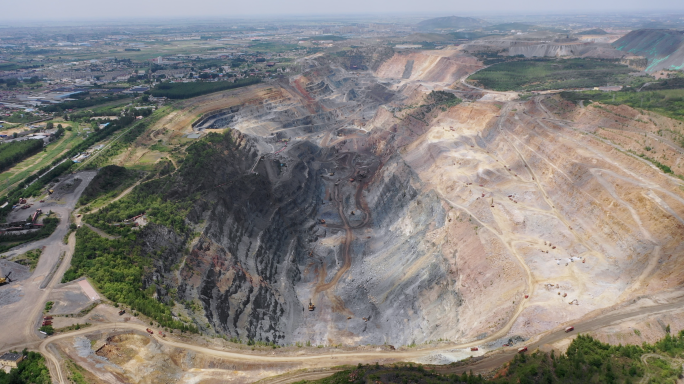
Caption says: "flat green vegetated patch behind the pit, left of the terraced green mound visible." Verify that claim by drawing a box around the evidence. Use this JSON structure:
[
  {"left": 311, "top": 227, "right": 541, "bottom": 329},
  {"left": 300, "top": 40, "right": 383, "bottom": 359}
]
[{"left": 469, "top": 59, "right": 632, "bottom": 91}]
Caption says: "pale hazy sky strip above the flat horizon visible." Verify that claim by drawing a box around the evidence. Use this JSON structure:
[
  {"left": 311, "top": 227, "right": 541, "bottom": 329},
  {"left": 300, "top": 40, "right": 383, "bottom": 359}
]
[{"left": 0, "top": 0, "right": 684, "bottom": 24}]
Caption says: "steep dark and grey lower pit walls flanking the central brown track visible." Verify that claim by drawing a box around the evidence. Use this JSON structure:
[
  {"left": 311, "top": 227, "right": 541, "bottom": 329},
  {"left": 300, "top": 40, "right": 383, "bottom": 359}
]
[{"left": 139, "top": 124, "right": 510, "bottom": 345}]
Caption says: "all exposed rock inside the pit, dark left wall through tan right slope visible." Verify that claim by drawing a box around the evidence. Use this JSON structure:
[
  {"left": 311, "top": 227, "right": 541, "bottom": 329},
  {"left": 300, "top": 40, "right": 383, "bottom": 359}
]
[{"left": 139, "top": 48, "right": 684, "bottom": 345}]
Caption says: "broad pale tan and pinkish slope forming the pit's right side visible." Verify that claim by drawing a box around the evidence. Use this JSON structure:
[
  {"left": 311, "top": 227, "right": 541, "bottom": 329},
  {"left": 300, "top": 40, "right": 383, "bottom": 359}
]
[{"left": 403, "top": 95, "right": 684, "bottom": 337}]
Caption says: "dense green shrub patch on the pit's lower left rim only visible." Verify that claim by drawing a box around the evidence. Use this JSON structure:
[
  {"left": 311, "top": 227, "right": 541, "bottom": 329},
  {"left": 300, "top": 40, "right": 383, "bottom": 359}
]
[{"left": 62, "top": 227, "right": 197, "bottom": 332}]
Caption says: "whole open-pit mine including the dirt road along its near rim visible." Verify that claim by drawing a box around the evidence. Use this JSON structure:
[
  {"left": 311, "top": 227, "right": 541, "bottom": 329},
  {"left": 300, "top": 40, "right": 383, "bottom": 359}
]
[{"left": 4, "top": 42, "right": 684, "bottom": 383}]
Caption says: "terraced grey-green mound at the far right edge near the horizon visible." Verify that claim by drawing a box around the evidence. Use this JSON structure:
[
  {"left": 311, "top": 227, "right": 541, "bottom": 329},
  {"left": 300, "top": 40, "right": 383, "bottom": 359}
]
[{"left": 612, "top": 29, "right": 684, "bottom": 72}]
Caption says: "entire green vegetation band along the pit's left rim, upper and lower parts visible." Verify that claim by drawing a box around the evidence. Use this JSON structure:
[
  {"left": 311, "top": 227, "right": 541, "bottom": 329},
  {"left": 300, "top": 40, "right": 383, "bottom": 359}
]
[{"left": 63, "top": 130, "right": 246, "bottom": 332}]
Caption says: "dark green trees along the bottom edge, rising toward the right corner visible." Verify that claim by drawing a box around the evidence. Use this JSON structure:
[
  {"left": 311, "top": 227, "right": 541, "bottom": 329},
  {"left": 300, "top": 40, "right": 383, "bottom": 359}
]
[{"left": 300, "top": 331, "right": 684, "bottom": 384}]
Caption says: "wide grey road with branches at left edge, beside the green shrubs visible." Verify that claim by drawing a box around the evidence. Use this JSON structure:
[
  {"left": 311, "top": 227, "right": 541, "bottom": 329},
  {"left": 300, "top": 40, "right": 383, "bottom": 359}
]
[{"left": 0, "top": 171, "right": 96, "bottom": 351}]
